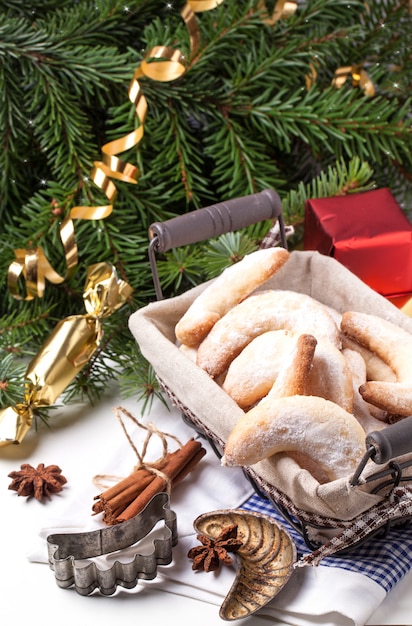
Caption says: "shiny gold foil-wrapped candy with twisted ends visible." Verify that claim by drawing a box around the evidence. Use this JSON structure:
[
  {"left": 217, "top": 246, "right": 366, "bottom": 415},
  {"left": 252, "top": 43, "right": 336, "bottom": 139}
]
[{"left": 0, "top": 263, "right": 133, "bottom": 447}]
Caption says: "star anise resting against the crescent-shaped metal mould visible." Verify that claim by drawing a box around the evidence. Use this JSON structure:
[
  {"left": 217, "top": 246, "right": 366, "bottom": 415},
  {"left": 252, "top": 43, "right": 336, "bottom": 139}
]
[{"left": 187, "top": 524, "right": 243, "bottom": 572}]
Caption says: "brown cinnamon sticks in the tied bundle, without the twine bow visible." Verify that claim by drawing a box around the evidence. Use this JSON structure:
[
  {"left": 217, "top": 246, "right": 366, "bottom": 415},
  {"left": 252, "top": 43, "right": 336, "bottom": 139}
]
[{"left": 92, "top": 439, "right": 206, "bottom": 526}]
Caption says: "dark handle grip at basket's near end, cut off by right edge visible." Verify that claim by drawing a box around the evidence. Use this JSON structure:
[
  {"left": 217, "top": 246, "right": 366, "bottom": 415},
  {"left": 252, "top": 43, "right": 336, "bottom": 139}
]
[{"left": 366, "top": 415, "right": 412, "bottom": 465}]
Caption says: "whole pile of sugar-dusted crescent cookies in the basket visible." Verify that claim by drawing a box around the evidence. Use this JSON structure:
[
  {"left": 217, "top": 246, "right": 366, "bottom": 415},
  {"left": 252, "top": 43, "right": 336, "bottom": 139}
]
[{"left": 175, "top": 248, "right": 412, "bottom": 482}]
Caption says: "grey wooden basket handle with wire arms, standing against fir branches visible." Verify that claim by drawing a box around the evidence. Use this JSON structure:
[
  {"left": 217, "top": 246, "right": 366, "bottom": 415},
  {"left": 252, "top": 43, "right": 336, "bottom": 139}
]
[{"left": 149, "top": 189, "right": 287, "bottom": 300}]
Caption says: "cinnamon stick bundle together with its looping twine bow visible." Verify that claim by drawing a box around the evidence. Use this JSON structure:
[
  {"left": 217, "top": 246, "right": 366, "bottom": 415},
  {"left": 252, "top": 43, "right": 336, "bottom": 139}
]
[{"left": 92, "top": 407, "right": 206, "bottom": 526}]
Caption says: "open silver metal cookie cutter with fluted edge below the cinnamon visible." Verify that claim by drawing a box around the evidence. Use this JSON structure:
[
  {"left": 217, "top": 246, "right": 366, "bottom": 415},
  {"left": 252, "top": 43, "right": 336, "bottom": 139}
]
[{"left": 47, "top": 492, "right": 177, "bottom": 596}]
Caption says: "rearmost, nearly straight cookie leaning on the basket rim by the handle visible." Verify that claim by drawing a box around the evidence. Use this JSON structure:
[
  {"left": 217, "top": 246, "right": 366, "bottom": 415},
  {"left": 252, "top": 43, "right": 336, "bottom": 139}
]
[{"left": 175, "top": 248, "right": 290, "bottom": 346}]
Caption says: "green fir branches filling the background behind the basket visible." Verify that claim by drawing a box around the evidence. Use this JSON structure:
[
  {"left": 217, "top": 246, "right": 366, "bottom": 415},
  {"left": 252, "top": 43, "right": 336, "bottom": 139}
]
[{"left": 0, "top": 0, "right": 412, "bottom": 418}]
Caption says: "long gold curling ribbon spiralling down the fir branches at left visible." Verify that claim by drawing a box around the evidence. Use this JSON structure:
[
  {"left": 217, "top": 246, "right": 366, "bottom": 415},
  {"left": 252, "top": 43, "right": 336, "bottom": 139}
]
[{"left": 7, "top": 0, "right": 224, "bottom": 300}]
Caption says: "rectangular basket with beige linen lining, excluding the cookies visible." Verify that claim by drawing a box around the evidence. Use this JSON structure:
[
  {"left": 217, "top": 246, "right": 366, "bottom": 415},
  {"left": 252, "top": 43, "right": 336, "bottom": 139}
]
[{"left": 129, "top": 192, "right": 412, "bottom": 563}]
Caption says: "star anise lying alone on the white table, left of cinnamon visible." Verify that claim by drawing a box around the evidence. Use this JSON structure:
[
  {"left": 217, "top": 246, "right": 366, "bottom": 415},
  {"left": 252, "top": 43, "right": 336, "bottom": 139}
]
[{"left": 9, "top": 463, "right": 67, "bottom": 501}]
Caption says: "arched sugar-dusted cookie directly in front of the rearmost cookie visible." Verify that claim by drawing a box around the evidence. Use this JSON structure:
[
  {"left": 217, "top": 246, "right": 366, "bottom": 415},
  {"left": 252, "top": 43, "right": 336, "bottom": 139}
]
[{"left": 196, "top": 289, "right": 340, "bottom": 378}]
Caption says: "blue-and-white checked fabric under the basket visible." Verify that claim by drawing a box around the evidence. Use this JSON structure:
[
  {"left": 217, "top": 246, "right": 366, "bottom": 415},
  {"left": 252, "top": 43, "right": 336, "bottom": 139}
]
[{"left": 242, "top": 494, "right": 412, "bottom": 592}]
